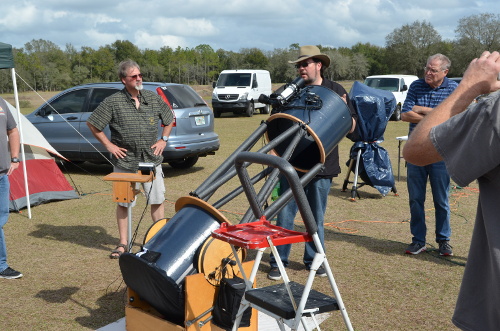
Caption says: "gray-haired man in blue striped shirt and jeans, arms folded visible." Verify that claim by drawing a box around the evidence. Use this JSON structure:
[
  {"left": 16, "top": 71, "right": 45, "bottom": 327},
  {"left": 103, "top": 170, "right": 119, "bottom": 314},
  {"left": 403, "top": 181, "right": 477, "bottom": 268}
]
[{"left": 401, "top": 54, "right": 458, "bottom": 256}]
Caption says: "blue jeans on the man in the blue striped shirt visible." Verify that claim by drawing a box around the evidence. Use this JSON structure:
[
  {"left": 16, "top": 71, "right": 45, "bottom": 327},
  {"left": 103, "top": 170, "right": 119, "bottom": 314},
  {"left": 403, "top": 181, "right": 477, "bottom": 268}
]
[{"left": 407, "top": 161, "right": 451, "bottom": 245}]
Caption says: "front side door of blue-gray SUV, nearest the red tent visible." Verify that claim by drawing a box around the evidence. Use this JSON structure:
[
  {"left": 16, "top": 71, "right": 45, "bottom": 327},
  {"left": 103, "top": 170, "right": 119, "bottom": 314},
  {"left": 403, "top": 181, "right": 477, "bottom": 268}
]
[{"left": 30, "top": 88, "right": 89, "bottom": 160}]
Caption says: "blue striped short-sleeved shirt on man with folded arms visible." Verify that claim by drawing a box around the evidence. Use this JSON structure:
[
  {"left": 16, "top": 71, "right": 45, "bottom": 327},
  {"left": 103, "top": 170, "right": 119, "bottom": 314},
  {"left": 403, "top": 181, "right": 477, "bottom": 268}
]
[{"left": 401, "top": 77, "right": 458, "bottom": 132}]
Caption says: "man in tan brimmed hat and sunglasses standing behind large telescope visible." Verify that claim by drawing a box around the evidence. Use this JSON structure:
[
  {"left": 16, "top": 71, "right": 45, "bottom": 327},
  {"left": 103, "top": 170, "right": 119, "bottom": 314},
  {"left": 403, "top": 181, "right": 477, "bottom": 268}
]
[{"left": 267, "top": 46, "right": 357, "bottom": 280}]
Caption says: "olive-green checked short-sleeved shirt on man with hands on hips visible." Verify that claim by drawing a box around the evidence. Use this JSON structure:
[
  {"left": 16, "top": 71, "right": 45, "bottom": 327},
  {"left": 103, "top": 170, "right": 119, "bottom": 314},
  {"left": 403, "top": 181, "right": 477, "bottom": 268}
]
[{"left": 88, "top": 88, "right": 173, "bottom": 171}]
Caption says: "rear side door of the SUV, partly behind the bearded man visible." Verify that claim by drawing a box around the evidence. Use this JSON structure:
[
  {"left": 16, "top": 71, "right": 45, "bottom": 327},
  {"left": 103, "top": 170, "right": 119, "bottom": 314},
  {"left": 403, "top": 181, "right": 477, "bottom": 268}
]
[{"left": 79, "top": 87, "right": 119, "bottom": 161}]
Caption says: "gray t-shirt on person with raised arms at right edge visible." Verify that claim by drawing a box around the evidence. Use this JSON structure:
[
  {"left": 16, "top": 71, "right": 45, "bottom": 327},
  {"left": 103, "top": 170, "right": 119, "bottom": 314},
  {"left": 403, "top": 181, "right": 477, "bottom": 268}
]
[{"left": 430, "top": 92, "right": 500, "bottom": 331}]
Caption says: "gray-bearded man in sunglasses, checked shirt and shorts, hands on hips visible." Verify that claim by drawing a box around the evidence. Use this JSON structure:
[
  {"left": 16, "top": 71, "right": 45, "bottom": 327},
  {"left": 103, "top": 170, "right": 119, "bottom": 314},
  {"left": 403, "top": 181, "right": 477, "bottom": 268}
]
[{"left": 87, "top": 60, "right": 173, "bottom": 259}]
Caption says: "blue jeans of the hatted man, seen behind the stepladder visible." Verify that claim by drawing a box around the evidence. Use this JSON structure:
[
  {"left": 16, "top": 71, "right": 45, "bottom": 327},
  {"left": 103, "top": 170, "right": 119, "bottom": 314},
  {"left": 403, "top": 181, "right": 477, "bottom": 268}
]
[{"left": 270, "top": 178, "right": 332, "bottom": 268}]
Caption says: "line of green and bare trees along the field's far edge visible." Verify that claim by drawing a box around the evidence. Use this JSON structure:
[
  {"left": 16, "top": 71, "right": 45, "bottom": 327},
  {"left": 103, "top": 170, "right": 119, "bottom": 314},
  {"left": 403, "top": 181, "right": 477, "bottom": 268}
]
[{"left": 0, "top": 13, "right": 500, "bottom": 93}]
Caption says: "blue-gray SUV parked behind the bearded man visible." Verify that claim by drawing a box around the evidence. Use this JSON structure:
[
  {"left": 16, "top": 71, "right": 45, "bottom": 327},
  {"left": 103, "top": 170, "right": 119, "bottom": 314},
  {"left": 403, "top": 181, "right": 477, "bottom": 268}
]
[{"left": 26, "top": 82, "right": 220, "bottom": 168}]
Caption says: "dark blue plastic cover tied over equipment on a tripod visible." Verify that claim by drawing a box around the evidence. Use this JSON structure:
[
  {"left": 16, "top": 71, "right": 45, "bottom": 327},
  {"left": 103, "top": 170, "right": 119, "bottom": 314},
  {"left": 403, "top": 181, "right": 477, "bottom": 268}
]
[{"left": 349, "top": 81, "right": 396, "bottom": 196}]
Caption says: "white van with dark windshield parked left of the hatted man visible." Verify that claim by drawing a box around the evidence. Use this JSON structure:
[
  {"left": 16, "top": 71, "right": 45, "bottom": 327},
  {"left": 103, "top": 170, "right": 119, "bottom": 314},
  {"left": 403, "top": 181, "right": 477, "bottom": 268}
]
[{"left": 212, "top": 69, "right": 272, "bottom": 117}]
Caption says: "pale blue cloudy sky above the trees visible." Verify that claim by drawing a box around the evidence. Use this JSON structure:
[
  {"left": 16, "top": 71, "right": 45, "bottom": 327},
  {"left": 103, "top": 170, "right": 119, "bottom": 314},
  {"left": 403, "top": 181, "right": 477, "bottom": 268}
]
[{"left": 0, "top": 0, "right": 500, "bottom": 51}]
